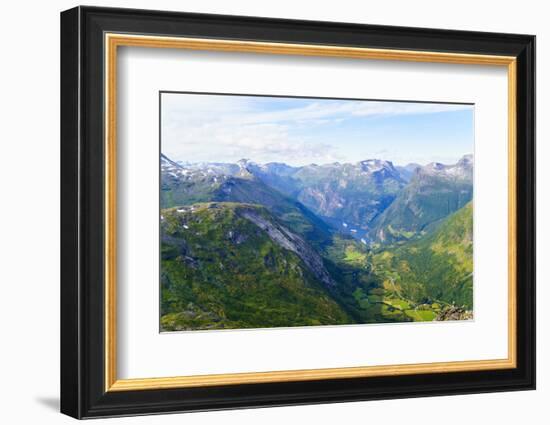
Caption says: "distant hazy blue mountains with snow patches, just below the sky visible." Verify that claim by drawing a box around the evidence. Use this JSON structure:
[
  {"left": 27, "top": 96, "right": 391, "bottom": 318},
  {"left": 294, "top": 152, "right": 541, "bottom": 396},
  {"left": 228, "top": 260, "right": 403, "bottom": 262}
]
[{"left": 161, "top": 155, "right": 473, "bottom": 241}]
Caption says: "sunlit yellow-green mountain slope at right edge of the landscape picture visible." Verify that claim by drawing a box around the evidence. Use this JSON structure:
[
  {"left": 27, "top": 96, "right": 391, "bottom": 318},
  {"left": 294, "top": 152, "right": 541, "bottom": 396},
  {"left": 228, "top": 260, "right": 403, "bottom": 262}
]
[{"left": 372, "top": 202, "right": 473, "bottom": 310}]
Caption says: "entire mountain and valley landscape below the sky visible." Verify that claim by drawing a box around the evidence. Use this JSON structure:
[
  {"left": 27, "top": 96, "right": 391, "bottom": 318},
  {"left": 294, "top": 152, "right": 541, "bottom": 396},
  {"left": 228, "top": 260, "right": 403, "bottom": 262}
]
[{"left": 160, "top": 154, "right": 473, "bottom": 331}]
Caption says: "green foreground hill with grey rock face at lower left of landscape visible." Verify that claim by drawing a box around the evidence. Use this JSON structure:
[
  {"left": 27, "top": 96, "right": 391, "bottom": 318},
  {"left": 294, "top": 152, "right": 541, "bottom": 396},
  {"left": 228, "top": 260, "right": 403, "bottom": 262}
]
[{"left": 161, "top": 202, "right": 353, "bottom": 331}]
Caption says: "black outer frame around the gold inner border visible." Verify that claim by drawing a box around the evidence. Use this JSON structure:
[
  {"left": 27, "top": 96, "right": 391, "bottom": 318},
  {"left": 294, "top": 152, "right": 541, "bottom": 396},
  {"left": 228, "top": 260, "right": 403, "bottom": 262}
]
[{"left": 61, "top": 7, "right": 535, "bottom": 418}]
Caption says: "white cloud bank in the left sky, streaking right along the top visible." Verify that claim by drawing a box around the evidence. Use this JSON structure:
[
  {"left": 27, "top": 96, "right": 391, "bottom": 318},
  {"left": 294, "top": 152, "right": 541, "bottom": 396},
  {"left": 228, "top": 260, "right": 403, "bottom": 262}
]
[{"left": 162, "top": 93, "right": 471, "bottom": 163}]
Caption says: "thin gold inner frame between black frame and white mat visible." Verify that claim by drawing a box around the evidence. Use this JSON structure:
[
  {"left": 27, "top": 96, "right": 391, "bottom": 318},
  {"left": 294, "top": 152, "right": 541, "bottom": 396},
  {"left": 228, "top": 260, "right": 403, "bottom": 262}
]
[{"left": 104, "top": 33, "right": 517, "bottom": 391}]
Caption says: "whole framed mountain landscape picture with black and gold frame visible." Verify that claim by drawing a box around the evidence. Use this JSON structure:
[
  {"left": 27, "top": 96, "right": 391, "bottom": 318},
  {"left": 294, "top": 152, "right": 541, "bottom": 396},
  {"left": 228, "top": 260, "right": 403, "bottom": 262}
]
[{"left": 61, "top": 7, "right": 535, "bottom": 418}]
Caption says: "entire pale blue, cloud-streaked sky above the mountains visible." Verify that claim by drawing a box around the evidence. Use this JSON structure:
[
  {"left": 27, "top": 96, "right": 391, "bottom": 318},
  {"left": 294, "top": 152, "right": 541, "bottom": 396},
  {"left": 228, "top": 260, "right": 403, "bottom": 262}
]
[{"left": 161, "top": 93, "right": 474, "bottom": 165}]
